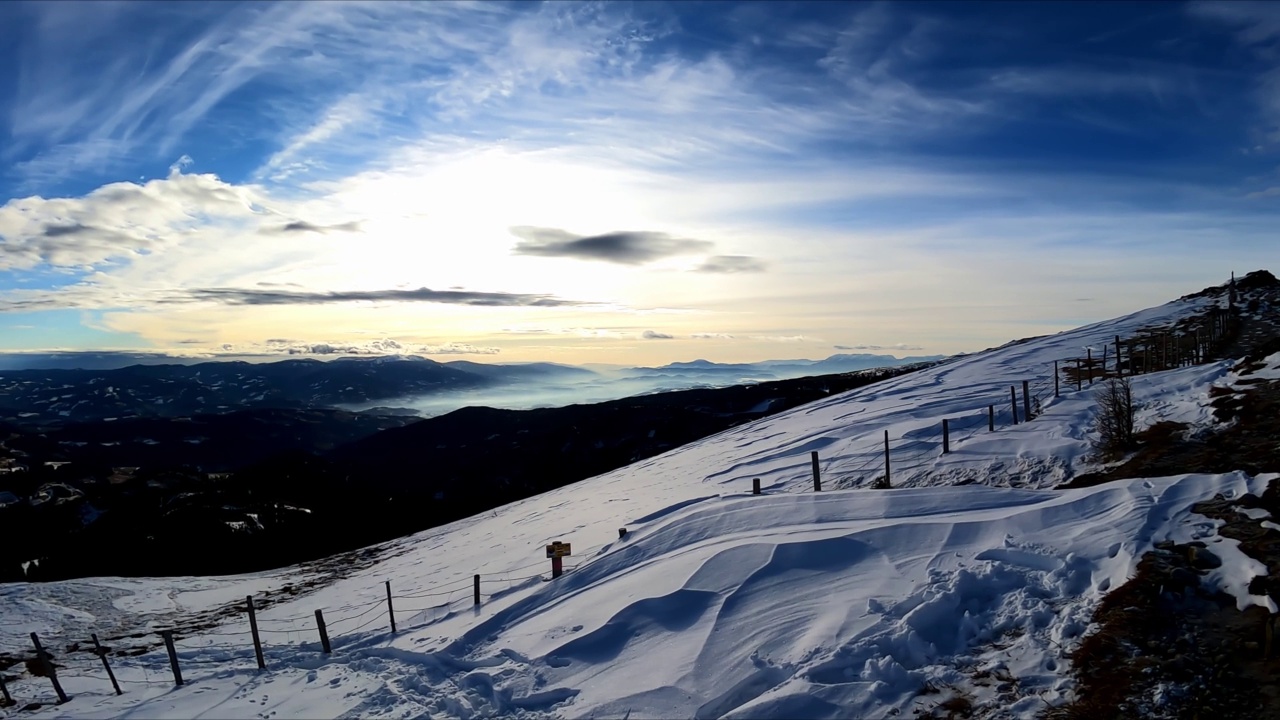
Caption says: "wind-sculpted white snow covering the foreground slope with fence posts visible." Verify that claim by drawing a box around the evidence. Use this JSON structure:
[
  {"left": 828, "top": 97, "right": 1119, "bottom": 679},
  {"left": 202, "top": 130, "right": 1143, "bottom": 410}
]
[{"left": 0, "top": 288, "right": 1265, "bottom": 717}]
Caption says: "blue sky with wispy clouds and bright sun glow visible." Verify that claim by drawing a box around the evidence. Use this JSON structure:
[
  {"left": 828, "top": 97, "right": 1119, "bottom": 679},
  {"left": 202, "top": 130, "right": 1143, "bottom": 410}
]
[{"left": 0, "top": 1, "right": 1280, "bottom": 364}]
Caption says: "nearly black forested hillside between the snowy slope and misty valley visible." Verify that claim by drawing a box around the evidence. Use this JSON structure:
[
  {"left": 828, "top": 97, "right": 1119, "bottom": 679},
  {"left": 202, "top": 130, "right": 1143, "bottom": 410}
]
[{"left": 0, "top": 366, "right": 942, "bottom": 580}]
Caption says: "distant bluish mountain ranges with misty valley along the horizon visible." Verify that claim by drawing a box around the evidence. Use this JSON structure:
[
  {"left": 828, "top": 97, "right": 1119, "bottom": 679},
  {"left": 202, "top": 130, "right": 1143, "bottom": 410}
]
[{"left": 0, "top": 354, "right": 940, "bottom": 427}]
